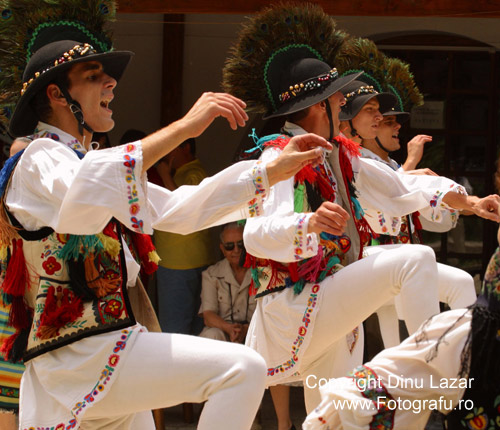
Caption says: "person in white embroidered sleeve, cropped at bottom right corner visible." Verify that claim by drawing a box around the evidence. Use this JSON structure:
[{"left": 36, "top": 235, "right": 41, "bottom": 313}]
[{"left": 303, "top": 170, "right": 500, "bottom": 430}]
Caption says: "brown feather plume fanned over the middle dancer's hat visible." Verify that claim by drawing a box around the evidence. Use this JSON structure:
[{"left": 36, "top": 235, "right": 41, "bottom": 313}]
[{"left": 222, "top": 2, "right": 347, "bottom": 113}]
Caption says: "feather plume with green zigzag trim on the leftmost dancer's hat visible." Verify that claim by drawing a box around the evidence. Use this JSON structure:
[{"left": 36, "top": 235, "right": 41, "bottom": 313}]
[{"left": 0, "top": 0, "right": 116, "bottom": 131}]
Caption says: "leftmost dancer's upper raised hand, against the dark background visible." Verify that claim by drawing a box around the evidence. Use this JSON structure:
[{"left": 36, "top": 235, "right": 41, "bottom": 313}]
[{"left": 178, "top": 93, "right": 248, "bottom": 139}]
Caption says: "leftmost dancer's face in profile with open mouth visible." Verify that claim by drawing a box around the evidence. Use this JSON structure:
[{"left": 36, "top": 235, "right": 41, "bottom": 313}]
[{"left": 68, "top": 61, "right": 116, "bottom": 132}]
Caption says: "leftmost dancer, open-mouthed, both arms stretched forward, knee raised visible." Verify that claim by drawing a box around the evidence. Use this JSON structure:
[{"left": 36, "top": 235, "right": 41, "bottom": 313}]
[{"left": 0, "top": 0, "right": 331, "bottom": 430}]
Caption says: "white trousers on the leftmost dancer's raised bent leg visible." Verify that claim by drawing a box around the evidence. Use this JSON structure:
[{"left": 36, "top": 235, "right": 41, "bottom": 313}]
[{"left": 75, "top": 333, "right": 266, "bottom": 430}]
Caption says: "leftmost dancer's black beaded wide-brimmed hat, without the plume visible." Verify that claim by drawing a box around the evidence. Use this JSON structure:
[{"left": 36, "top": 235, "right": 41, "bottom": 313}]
[{"left": 9, "top": 40, "right": 133, "bottom": 137}]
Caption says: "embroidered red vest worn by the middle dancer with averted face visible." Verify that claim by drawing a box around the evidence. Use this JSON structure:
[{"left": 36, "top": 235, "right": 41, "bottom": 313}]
[{"left": 246, "top": 136, "right": 370, "bottom": 297}]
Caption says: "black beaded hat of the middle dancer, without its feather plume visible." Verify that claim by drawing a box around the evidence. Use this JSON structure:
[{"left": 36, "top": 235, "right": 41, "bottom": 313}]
[{"left": 263, "top": 55, "right": 362, "bottom": 119}]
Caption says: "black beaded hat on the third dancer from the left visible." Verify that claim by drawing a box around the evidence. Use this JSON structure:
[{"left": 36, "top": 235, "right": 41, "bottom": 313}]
[{"left": 339, "top": 79, "right": 397, "bottom": 121}]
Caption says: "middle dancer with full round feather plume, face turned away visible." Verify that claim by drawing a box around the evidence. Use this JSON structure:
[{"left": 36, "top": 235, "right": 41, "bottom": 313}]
[{"left": 224, "top": 5, "right": 500, "bottom": 411}]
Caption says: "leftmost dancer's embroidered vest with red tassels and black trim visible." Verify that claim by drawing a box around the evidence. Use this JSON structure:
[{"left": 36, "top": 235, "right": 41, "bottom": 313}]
[{"left": 0, "top": 149, "right": 157, "bottom": 362}]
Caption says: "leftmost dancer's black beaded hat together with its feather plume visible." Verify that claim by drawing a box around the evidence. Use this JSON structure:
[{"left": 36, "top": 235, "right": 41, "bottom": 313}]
[{"left": 0, "top": 0, "right": 133, "bottom": 136}]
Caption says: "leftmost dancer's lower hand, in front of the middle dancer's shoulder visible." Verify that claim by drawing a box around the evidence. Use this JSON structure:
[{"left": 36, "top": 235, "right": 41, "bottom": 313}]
[{"left": 266, "top": 133, "right": 332, "bottom": 186}]
